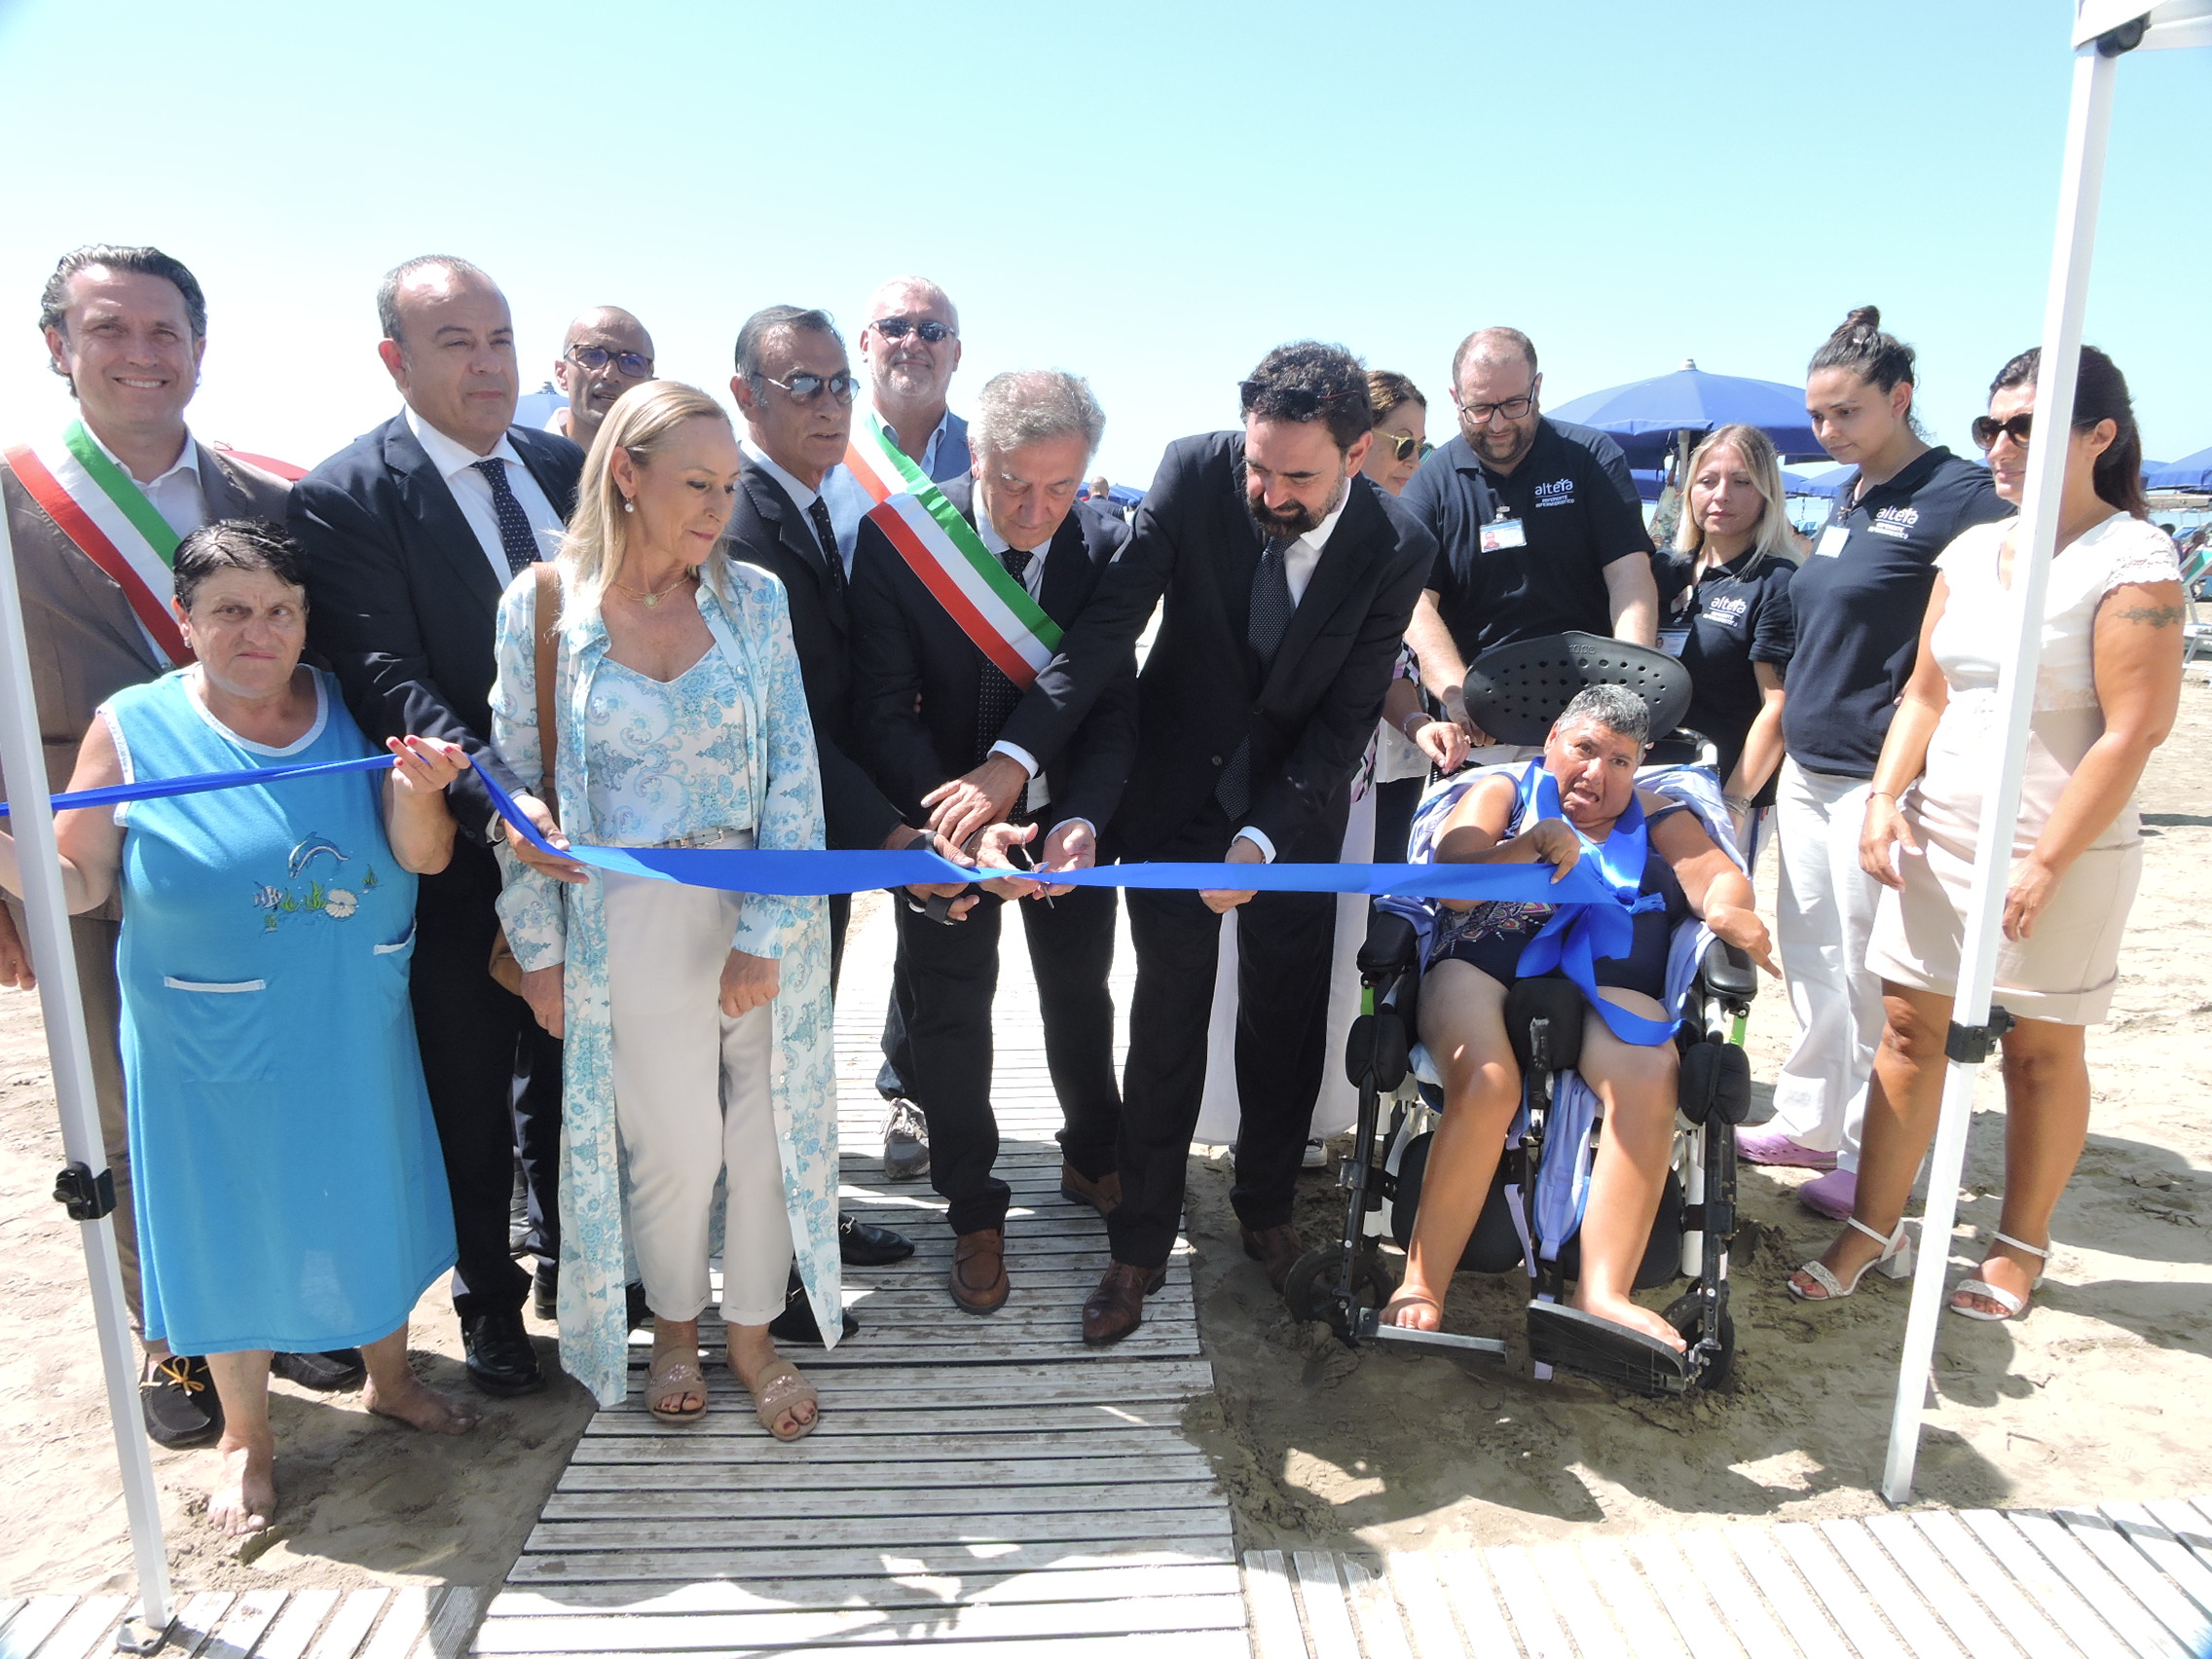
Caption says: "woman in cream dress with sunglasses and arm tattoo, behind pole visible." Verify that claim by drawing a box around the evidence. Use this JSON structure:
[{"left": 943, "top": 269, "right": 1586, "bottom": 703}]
[{"left": 1789, "top": 345, "right": 2183, "bottom": 1318}]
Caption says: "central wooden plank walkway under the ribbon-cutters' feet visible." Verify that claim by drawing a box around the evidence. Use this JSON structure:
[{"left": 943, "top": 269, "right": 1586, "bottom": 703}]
[{"left": 471, "top": 911, "right": 1247, "bottom": 1659}]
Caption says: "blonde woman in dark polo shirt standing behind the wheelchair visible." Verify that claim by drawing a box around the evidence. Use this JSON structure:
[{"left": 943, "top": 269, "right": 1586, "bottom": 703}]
[{"left": 1652, "top": 426, "right": 1796, "bottom": 854}]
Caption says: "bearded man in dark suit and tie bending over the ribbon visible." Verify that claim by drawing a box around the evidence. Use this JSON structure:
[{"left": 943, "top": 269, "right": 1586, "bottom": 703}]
[{"left": 938, "top": 341, "right": 1436, "bottom": 1343}]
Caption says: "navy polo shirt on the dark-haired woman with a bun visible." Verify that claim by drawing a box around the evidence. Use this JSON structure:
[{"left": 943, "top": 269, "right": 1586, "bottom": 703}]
[{"left": 1783, "top": 447, "right": 2013, "bottom": 779}]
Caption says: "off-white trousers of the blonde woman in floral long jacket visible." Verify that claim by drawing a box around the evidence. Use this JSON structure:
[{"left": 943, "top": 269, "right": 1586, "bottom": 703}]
[{"left": 600, "top": 836, "right": 792, "bottom": 1325}]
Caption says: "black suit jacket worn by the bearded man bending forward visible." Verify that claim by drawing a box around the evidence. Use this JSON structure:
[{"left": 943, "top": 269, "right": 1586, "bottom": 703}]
[{"left": 1002, "top": 431, "right": 1436, "bottom": 861}]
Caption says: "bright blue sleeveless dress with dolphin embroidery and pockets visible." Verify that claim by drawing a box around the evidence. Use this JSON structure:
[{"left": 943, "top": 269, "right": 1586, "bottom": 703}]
[{"left": 99, "top": 668, "right": 454, "bottom": 1353}]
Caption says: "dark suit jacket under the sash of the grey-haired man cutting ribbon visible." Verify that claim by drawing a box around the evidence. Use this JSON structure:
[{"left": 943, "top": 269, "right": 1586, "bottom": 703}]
[{"left": 852, "top": 478, "right": 1137, "bottom": 830}]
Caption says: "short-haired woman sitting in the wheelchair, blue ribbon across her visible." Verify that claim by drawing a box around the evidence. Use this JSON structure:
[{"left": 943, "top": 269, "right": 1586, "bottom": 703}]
[{"left": 1382, "top": 685, "right": 1776, "bottom": 1351}]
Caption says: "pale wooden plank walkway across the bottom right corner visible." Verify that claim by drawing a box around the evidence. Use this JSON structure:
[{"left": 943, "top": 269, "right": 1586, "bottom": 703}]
[{"left": 1243, "top": 1499, "right": 2212, "bottom": 1659}]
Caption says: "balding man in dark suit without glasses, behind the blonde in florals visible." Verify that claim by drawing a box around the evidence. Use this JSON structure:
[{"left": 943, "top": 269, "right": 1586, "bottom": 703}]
[{"left": 290, "top": 257, "right": 584, "bottom": 1396}]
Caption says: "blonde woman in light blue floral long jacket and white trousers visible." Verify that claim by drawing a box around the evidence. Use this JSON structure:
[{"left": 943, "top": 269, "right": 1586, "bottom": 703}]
[{"left": 491, "top": 381, "right": 840, "bottom": 1440}]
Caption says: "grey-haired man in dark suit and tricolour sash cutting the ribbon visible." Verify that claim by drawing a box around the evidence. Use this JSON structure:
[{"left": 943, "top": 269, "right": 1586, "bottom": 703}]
[{"left": 852, "top": 372, "right": 1137, "bottom": 1314}]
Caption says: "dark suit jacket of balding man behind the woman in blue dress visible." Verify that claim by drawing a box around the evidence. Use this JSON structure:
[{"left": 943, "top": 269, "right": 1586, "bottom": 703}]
[{"left": 290, "top": 414, "right": 584, "bottom": 834}]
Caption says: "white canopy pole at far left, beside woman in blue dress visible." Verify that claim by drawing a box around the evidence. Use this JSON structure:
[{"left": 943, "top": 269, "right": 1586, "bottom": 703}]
[{"left": 0, "top": 513, "right": 170, "bottom": 1650}]
